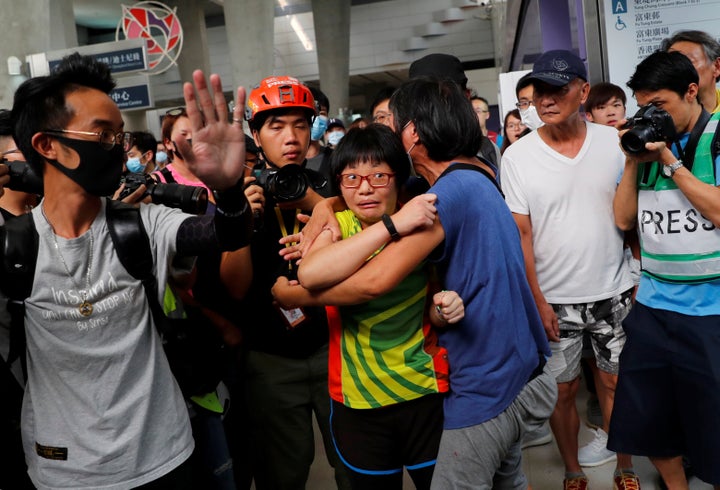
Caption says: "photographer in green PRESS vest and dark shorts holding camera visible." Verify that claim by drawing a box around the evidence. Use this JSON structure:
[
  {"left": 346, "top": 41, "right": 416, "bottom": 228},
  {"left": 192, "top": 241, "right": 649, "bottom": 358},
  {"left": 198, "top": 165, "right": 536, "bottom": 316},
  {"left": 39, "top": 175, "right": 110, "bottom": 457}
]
[{"left": 608, "top": 52, "right": 720, "bottom": 488}]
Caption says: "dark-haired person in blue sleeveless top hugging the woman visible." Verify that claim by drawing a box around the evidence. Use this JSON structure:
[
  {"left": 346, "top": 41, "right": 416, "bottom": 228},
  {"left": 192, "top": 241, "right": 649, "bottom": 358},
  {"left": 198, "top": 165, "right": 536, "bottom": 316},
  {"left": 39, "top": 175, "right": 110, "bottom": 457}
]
[{"left": 282, "top": 78, "right": 557, "bottom": 489}]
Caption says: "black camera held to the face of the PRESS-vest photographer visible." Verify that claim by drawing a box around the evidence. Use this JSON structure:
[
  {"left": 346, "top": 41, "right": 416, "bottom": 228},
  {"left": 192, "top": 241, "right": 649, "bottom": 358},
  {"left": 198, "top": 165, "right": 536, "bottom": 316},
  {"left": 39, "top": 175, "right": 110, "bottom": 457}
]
[{"left": 620, "top": 104, "right": 676, "bottom": 155}]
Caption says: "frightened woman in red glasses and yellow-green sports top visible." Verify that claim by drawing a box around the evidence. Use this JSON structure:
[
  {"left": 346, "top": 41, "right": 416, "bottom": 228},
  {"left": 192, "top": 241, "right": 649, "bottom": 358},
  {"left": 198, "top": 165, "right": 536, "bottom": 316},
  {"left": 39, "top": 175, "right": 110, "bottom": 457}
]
[{"left": 273, "top": 124, "right": 464, "bottom": 490}]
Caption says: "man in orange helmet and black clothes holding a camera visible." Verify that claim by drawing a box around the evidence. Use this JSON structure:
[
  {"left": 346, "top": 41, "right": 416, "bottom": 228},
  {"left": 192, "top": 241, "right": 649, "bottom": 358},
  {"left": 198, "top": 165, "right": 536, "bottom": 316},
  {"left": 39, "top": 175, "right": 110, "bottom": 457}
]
[{"left": 236, "top": 77, "right": 349, "bottom": 490}]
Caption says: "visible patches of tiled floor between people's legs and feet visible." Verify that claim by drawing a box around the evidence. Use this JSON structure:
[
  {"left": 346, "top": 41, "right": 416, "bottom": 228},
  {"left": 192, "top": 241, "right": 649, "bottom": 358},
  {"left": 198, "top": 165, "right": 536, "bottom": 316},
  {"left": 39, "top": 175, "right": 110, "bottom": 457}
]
[{"left": 300, "top": 388, "right": 712, "bottom": 490}]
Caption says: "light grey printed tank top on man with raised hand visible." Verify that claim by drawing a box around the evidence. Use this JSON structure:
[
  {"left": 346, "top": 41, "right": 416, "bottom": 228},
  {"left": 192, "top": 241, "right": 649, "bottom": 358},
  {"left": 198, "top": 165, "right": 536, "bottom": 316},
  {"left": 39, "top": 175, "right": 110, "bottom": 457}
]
[{"left": 22, "top": 200, "right": 194, "bottom": 490}]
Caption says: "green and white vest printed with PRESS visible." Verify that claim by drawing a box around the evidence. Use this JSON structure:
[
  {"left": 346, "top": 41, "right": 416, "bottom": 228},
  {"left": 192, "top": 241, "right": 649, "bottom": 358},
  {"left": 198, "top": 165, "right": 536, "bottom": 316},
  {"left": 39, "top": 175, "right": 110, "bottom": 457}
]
[{"left": 638, "top": 113, "right": 720, "bottom": 283}]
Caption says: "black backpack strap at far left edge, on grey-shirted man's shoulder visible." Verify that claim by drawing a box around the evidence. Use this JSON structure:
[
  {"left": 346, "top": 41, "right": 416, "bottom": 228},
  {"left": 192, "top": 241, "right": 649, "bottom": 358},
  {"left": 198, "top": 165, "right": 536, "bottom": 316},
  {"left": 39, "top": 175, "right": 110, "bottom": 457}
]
[{"left": 0, "top": 213, "right": 39, "bottom": 374}]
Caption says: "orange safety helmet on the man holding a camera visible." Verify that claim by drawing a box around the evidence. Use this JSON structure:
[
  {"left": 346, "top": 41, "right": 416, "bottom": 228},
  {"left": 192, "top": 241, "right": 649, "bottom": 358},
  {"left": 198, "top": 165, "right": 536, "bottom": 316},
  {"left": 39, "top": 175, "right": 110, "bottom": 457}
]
[{"left": 245, "top": 76, "right": 317, "bottom": 122}]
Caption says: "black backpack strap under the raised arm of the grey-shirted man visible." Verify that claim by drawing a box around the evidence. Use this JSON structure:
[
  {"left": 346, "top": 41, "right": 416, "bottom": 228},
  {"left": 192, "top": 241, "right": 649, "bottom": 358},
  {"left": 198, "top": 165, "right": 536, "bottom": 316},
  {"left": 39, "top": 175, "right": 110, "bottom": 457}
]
[{"left": 105, "top": 199, "right": 165, "bottom": 333}]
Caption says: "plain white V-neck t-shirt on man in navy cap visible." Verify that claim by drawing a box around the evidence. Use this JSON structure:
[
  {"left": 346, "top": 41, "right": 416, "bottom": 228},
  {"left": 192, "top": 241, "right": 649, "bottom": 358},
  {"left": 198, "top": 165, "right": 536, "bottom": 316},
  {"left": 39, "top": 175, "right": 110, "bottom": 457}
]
[{"left": 501, "top": 123, "right": 633, "bottom": 304}]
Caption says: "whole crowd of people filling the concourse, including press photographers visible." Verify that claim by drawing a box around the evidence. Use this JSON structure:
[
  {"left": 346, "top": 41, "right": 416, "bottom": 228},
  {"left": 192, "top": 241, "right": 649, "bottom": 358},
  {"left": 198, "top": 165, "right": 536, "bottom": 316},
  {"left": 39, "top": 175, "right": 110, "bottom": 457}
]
[{"left": 0, "top": 25, "right": 720, "bottom": 490}]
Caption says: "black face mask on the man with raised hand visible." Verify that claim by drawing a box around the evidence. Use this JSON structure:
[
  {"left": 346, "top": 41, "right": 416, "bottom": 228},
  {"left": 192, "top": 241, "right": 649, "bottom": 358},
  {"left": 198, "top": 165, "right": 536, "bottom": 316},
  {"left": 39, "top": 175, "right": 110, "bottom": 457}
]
[{"left": 49, "top": 136, "right": 125, "bottom": 196}]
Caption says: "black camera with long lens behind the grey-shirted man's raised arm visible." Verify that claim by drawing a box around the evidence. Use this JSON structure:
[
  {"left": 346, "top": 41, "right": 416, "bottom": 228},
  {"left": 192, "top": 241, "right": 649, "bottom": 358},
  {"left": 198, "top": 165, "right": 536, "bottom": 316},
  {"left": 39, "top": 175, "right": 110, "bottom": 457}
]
[{"left": 118, "top": 174, "right": 208, "bottom": 214}]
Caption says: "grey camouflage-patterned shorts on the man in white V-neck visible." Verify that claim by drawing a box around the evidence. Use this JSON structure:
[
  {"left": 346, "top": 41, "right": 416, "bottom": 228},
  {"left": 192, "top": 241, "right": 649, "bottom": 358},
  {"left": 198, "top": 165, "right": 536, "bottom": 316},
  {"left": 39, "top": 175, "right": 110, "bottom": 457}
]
[{"left": 548, "top": 290, "right": 632, "bottom": 383}]
